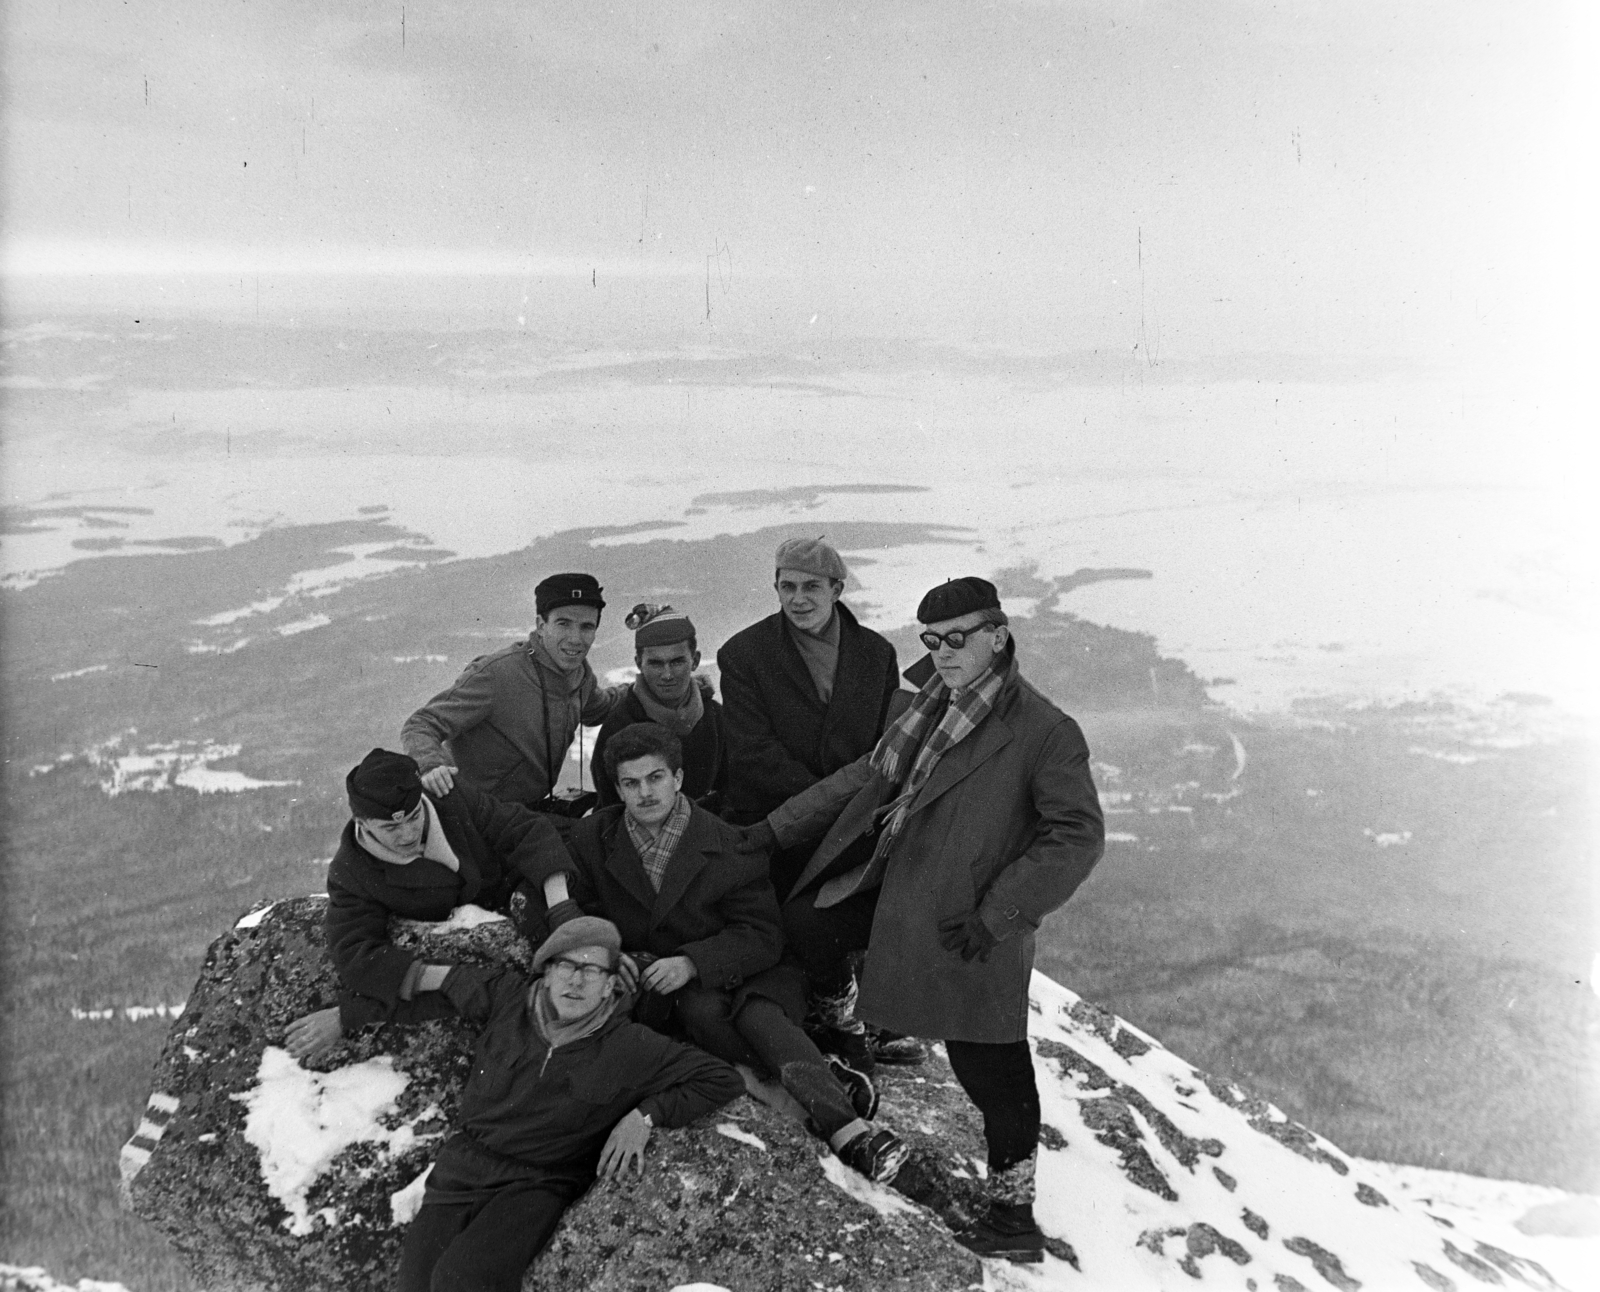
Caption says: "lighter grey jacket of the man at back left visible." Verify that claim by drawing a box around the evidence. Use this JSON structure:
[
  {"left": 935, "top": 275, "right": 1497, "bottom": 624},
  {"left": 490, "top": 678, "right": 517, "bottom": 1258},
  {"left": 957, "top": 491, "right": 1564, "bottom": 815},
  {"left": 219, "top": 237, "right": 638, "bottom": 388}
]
[{"left": 400, "top": 636, "right": 622, "bottom": 808}]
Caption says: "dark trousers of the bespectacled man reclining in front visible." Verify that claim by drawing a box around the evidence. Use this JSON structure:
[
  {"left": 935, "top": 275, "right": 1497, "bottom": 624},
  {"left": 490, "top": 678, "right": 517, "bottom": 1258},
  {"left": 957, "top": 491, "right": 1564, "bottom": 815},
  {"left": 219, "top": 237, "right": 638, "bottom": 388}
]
[{"left": 395, "top": 1182, "right": 581, "bottom": 1292}]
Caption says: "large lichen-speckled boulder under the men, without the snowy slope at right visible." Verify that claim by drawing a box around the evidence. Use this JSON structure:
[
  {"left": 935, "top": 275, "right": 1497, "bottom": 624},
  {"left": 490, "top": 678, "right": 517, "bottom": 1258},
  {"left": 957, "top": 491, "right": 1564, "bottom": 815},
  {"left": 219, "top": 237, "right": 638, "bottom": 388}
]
[{"left": 122, "top": 897, "right": 982, "bottom": 1292}]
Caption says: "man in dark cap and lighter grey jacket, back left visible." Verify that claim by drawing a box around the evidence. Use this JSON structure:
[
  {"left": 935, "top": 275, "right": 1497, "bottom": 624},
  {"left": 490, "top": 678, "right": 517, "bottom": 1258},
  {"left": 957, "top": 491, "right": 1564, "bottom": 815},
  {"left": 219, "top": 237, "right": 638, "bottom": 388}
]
[{"left": 400, "top": 574, "right": 629, "bottom": 817}]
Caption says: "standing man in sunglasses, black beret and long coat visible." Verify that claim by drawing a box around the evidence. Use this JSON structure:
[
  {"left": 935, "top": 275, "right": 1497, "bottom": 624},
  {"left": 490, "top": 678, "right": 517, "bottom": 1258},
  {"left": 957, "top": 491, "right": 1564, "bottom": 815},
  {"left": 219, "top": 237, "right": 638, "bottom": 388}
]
[{"left": 747, "top": 577, "right": 1106, "bottom": 1262}]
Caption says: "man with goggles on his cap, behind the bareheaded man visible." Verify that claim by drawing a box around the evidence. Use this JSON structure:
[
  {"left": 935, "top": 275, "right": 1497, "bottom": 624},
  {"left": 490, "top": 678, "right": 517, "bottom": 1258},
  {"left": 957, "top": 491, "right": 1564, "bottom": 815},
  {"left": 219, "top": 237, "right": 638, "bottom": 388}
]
[{"left": 590, "top": 603, "right": 728, "bottom": 812}]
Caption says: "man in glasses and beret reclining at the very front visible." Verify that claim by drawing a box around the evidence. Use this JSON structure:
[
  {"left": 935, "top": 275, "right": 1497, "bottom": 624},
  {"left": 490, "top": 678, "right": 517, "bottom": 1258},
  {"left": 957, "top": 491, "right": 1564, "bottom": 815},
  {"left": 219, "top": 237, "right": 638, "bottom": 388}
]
[{"left": 380, "top": 916, "right": 744, "bottom": 1292}]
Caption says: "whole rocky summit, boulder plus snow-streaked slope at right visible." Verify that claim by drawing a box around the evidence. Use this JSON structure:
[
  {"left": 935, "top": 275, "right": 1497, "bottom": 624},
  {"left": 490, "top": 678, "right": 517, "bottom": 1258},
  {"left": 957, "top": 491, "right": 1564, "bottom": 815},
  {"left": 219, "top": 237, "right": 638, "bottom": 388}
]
[{"left": 123, "top": 899, "right": 1555, "bottom": 1292}]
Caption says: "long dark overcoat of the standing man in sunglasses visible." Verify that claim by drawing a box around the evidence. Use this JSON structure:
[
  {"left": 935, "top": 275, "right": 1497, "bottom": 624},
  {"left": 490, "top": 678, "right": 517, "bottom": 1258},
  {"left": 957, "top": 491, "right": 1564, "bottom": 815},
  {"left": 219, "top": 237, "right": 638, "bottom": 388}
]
[{"left": 771, "top": 656, "right": 1106, "bottom": 1043}]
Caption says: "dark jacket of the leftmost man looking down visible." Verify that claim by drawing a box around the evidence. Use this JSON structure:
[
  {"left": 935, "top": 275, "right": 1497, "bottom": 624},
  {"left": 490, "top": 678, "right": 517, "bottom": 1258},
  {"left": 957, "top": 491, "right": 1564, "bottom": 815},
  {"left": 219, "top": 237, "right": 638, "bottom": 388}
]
[{"left": 325, "top": 782, "right": 573, "bottom": 1030}]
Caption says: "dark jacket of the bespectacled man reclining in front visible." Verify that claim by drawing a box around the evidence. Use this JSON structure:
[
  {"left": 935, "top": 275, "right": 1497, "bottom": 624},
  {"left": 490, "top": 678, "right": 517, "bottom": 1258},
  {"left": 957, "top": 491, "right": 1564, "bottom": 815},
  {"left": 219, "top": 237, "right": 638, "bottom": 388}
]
[{"left": 395, "top": 964, "right": 744, "bottom": 1202}]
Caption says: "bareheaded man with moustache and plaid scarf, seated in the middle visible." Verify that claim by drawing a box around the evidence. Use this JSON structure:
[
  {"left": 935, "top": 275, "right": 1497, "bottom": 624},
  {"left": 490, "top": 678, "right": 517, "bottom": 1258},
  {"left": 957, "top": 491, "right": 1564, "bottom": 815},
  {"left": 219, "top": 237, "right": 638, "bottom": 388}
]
[{"left": 542, "top": 723, "right": 909, "bottom": 1182}]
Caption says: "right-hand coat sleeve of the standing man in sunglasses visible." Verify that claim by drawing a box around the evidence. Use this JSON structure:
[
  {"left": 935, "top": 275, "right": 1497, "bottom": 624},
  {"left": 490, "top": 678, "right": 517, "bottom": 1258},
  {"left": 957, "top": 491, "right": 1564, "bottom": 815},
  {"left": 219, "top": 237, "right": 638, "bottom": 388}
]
[{"left": 978, "top": 718, "right": 1106, "bottom": 939}]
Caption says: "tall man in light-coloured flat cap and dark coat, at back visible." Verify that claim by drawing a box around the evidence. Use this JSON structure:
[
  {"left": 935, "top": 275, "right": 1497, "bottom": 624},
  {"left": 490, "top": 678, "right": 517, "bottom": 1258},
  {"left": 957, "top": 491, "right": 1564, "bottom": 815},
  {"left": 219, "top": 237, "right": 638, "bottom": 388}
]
[{"left": 717, "top": 537, "right": 899, "bottom": 900}]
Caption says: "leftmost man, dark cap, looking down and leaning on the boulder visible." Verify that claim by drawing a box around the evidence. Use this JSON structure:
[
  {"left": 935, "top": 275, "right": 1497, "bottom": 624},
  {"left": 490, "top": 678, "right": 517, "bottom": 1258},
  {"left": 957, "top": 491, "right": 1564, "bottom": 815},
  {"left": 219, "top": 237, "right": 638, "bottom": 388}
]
[{"left": 288, "top": 750, "right": 571, "bottom": 1059}]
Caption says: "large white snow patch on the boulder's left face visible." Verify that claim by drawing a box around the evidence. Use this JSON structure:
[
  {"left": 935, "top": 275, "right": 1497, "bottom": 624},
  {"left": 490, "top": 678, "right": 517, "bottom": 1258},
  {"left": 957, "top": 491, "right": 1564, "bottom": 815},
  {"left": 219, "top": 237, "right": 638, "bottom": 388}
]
[{"left": 229, "top": 1046, "right": 414, "bottom": 1236}]
